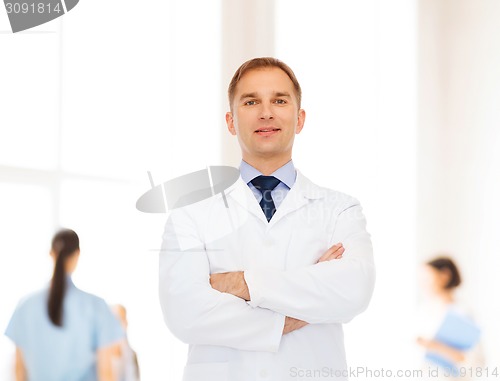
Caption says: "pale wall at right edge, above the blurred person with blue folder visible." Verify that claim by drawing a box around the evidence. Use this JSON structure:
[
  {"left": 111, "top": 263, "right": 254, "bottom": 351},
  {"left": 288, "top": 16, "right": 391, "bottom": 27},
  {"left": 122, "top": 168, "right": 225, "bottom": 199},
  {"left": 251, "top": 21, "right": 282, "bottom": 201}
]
[{"left": 417, "top": 0, "right": 500, "bottom": 365}]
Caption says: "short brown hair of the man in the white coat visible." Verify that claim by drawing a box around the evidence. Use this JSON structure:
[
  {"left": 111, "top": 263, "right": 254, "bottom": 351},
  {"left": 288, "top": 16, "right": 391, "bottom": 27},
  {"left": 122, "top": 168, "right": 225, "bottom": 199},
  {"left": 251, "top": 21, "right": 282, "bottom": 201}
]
[{"left": 227, "top": 57, "right": 302, "bottom": 109}]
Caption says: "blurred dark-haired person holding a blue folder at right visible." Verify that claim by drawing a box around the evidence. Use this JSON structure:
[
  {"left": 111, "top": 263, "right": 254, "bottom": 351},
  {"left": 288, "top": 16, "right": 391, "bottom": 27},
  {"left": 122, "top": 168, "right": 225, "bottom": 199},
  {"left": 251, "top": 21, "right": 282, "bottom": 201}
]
[{"left": 417, "top": 256, "right": 484, "bottom": 381}]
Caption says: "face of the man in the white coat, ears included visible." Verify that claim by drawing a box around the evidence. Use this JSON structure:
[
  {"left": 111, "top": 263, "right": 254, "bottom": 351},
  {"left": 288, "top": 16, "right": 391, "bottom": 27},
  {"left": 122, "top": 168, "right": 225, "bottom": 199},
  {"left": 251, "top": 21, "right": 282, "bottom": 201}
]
[{"left": 226, "top": 68, "right": 305, "bottom": 162}]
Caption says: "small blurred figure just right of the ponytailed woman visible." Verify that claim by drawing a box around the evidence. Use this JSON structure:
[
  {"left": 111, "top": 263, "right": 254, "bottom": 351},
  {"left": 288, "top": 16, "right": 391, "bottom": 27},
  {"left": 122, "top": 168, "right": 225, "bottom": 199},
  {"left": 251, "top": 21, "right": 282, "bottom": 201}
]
[{"left": 112, "top": 304, "right": 140, "bottom": 381}]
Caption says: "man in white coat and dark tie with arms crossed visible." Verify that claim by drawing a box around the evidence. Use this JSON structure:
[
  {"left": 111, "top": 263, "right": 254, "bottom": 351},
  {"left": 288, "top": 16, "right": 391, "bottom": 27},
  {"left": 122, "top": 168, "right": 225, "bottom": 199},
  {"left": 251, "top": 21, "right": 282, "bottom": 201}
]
[{"left": 159, "top": 58, "right": 375, "bottom": 381}]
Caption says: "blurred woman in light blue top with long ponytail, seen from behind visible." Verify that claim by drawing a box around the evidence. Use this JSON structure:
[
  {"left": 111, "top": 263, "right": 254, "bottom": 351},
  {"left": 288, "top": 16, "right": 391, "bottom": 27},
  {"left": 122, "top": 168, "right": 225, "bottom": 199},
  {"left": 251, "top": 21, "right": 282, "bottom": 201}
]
[{"left": 5, "top": 229, "right": 124, "bottom": 381}]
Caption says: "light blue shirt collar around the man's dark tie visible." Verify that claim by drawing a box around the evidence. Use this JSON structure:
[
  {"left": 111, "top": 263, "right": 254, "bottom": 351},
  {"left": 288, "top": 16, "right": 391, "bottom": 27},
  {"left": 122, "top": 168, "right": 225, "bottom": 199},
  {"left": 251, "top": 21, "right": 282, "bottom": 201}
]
[{"left": 240, "top": 160, "right": 297, "bottom": 210}]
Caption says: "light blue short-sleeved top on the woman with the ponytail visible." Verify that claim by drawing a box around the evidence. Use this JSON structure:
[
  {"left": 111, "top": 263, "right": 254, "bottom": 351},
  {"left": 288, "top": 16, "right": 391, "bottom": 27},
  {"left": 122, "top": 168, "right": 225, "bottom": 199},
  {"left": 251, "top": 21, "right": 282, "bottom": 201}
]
[{"left": 5, "top": 278, "right": 125, "bottom": 381}]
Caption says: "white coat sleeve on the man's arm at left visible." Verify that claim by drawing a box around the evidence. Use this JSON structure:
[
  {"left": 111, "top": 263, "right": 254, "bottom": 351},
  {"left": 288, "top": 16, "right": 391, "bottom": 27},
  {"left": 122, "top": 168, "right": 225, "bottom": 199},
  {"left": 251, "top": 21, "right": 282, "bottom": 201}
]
[{"left": 159, "top": 209, "right": 285, "bottom": 352}]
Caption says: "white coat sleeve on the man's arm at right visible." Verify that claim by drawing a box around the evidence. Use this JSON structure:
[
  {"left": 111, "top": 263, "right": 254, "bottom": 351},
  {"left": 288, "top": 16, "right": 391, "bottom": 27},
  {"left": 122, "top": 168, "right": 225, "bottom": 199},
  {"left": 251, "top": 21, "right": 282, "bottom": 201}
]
[{"left": 244, "top": 199, "right": 375, "bottom": 324}]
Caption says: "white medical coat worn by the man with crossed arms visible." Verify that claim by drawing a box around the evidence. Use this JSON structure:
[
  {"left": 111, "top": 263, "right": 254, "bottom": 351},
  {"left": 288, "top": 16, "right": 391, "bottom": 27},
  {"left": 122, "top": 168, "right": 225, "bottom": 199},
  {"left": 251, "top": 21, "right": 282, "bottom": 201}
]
[{"left": 159, "top": 172, "right": 375, "bottom": 381}]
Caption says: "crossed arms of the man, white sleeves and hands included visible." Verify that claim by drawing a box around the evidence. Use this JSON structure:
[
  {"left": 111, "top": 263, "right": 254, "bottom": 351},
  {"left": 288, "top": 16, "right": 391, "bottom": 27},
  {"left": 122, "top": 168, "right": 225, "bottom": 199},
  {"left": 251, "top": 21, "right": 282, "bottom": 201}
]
[{"left": 159, "top": 203, "right": 374, "bottom": 352}]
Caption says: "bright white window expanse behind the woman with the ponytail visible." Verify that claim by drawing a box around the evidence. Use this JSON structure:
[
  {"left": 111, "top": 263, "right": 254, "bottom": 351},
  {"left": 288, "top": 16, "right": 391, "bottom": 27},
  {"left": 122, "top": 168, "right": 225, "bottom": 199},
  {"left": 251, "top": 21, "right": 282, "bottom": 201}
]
[{"left": 0, "top": 0, "right": 224, "bottom": 381}]
